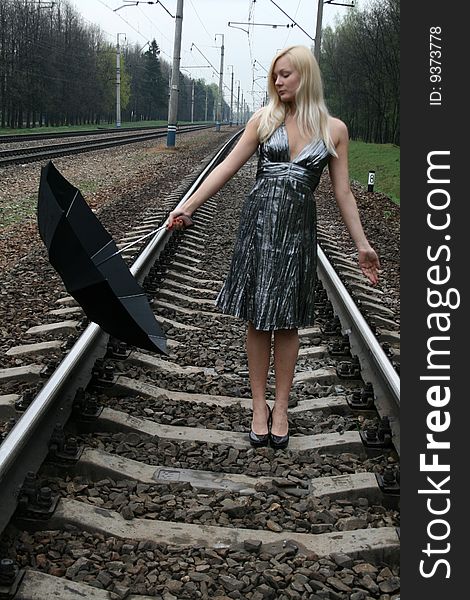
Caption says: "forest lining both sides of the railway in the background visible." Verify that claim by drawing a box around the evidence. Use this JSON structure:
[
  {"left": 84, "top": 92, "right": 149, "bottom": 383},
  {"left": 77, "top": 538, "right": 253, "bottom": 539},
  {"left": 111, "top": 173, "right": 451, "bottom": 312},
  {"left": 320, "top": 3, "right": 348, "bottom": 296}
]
[{"left": 0, "top": 0, "right": 400, "bottom": 144}]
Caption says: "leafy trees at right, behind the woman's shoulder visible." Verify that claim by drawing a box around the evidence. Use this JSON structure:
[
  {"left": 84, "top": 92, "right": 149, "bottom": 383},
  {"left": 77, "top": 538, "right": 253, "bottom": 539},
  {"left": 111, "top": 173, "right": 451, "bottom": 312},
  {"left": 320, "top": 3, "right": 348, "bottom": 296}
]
[{"left": 320, "top": 0, "right": 400, "bottom": 145}]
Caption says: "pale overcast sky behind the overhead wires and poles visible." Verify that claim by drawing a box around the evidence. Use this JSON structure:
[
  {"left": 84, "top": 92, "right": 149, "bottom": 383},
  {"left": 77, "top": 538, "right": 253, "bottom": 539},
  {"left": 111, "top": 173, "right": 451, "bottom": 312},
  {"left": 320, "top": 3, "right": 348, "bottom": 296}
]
[{"left": 69, "top": 0, "right": 367, "bottom": 110}]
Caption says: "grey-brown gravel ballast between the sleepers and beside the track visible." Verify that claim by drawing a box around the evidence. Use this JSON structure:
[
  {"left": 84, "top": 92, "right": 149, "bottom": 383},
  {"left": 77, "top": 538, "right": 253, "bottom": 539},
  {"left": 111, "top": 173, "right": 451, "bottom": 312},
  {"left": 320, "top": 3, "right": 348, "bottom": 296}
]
[{"left": 0, "top": 128, "right": 400, "bottom": 600}]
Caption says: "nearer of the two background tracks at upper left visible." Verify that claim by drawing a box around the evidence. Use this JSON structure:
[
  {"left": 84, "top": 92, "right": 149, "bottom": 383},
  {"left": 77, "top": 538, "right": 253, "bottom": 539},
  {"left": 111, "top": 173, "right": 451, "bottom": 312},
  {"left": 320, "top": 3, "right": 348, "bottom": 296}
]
[{"left": 0, "top": 125, "right": 211, "bottom": 167}]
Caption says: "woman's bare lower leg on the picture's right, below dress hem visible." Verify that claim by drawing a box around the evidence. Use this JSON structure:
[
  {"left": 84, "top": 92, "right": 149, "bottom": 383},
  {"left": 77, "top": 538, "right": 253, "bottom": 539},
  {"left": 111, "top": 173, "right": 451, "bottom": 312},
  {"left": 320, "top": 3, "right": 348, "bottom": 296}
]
[{"left": 271, "top": 329, "right": 299, "bottom": 436}]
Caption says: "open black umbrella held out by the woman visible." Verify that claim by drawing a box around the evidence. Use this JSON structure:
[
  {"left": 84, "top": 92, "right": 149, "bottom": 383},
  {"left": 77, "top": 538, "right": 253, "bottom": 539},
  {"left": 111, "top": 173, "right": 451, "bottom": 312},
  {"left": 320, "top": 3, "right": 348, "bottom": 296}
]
[{"left": 38, "top": 162, "right": 167, "bottom": 354}]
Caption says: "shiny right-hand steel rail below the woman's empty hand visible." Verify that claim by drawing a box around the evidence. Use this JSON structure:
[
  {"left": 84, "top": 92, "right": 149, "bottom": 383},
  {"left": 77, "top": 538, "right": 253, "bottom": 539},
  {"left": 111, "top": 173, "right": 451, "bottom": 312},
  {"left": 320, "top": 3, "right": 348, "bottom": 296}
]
[{"left": 318, "top": 247, "right": 400, "bottom": 454}]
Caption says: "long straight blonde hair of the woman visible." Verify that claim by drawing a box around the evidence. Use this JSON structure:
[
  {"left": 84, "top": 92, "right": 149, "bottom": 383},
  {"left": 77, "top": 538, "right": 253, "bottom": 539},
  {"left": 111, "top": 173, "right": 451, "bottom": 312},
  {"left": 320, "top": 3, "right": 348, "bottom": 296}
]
[{"left": 255, "top": 46, "right": 336, "bottom": 156}]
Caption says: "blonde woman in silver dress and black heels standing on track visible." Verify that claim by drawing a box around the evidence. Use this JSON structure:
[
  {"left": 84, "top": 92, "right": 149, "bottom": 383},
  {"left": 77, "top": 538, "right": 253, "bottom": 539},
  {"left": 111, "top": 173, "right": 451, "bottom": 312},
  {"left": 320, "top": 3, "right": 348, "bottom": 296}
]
[{"left": 167, "top": 46, "right": 380, "bottom": 448}]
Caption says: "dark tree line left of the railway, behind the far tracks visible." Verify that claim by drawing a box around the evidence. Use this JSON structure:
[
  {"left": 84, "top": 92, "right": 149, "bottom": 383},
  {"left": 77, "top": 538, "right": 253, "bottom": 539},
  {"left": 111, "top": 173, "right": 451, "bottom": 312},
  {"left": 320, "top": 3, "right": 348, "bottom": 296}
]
[{"left": 0, "top": 0, "right": 228, "bottom": 128}]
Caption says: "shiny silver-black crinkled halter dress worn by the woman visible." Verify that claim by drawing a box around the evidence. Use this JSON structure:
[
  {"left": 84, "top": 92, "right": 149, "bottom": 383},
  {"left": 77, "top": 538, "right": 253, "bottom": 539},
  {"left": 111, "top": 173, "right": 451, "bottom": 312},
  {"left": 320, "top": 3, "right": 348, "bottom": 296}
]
[{"left": 216, "top": 124, "right": 330, "bottom": 331}]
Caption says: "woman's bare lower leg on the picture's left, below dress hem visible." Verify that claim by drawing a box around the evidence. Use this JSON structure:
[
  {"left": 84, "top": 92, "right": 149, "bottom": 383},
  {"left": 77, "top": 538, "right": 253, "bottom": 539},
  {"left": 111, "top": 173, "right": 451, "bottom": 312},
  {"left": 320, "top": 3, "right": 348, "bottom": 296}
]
[{"left": 246, "top": 323, "right": 271, "bottom": 435}]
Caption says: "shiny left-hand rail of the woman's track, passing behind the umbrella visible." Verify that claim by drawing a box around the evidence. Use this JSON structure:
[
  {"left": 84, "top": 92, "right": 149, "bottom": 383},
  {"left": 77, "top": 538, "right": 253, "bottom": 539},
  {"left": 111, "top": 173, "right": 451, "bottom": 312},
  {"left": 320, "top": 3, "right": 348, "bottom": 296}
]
[{"left": 0, "top": 130, "right": 242, "bottom": 531}]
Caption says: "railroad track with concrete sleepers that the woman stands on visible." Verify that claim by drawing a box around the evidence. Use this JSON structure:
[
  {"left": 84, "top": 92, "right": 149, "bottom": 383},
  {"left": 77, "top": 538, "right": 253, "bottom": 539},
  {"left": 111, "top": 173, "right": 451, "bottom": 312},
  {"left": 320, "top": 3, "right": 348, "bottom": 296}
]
[{"left": 0, "top": 135, "right": 400, "bottom": 600}]
